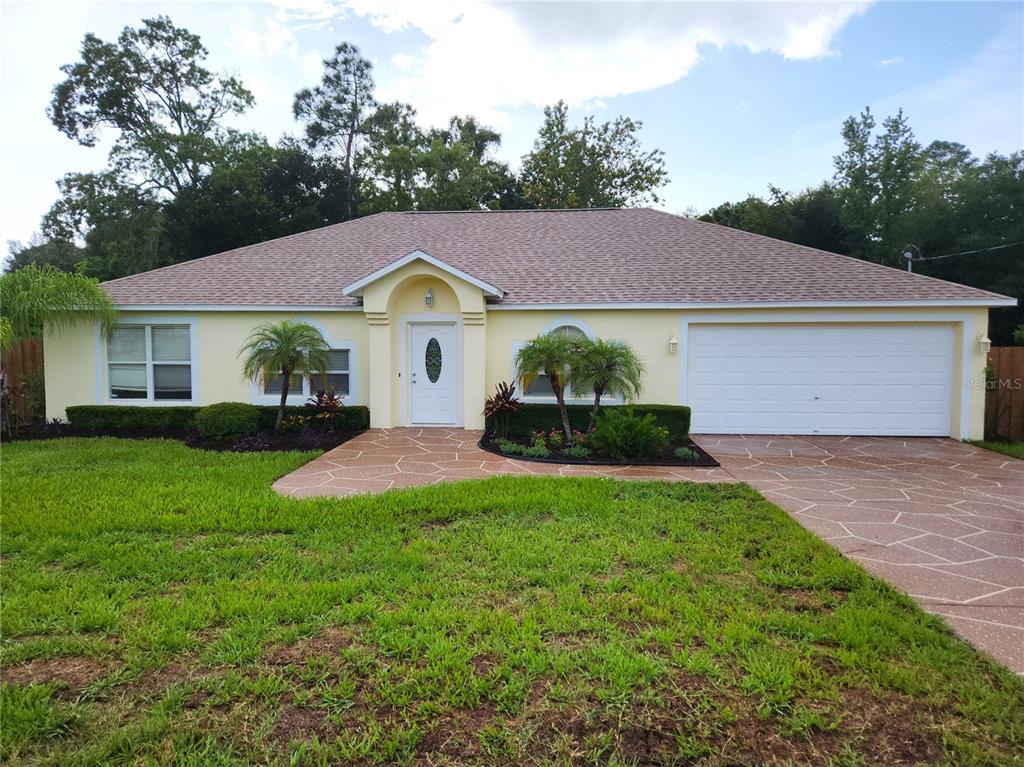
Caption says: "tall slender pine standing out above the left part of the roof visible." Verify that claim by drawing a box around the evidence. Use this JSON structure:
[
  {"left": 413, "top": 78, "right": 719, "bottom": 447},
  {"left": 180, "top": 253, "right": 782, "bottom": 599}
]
[{"left": 292, "top": 43, "right": 376, "bottom": 219}]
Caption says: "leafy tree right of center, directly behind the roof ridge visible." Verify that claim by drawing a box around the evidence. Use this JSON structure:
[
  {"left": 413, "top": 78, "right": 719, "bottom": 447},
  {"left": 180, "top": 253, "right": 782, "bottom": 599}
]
[{"left": 522, "top": 101, "right": 668, "bottom": 208}]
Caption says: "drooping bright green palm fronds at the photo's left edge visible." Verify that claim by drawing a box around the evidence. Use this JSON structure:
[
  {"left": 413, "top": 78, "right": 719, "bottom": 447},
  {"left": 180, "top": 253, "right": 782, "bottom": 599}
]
[{"left": 0, "top": 263, "right": 118, "bottom": 349}]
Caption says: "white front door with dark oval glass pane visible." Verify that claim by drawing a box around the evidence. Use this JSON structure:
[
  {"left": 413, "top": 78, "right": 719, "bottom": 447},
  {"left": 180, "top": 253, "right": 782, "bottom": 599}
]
[{"left": 409, "top": 324, "right": 462, "bottom": 425}]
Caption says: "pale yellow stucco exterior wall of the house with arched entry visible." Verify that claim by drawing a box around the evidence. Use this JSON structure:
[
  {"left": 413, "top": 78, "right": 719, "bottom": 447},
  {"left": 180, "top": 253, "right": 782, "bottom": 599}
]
[{"left": 44, "top": 296, "right": 988, "bottom": 438}]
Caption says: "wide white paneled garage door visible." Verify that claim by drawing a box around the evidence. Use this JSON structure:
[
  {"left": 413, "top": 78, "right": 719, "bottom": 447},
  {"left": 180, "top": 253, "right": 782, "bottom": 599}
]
[{"left": 686, "top": 325, "right": 953, "bottom": 436}]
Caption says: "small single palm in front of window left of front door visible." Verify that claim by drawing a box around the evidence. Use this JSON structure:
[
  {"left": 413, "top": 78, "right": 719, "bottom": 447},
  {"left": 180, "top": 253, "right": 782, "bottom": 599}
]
[{"left": 239, "top": 319, "right": 329, "bottom": 430}]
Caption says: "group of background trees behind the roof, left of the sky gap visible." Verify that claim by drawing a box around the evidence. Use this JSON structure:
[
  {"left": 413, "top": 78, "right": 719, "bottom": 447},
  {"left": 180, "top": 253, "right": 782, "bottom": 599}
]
[{"left": 10, "top": 16, "right": 666, "bottom": 280}]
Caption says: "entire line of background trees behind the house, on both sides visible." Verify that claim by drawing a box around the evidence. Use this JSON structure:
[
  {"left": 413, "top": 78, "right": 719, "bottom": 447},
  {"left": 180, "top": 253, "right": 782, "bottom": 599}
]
[{"left": 9, "top": 16, "right": 1024, "bottom": 343}]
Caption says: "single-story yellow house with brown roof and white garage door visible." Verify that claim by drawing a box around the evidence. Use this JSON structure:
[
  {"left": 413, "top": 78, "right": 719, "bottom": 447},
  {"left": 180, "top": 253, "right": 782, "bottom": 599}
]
[{"left": 45, "top": 209, "right": 1016, "bottom": 438}]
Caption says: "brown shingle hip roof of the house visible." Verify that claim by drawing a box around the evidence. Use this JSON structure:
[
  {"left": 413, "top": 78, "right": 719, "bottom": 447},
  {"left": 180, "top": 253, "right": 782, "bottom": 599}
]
[{"left": 103, "top": 208, "right": 1005, "bottom": 306}]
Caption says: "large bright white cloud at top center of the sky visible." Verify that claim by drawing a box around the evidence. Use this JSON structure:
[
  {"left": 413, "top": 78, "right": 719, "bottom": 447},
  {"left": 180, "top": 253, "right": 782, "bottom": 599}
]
[{"left": 278, "top": 0, "right": 867, "bottom": 124}]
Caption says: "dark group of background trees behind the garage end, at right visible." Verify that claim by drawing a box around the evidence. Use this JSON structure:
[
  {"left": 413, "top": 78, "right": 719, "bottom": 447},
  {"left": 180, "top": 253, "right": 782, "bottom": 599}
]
[{"left": 700, "top": 110, "right": 1024, "bottom": 345}]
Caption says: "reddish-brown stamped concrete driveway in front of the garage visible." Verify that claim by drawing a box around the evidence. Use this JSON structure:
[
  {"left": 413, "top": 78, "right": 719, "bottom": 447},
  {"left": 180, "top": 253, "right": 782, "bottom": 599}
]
[{"left": 697, "top": 436, "right": 1024, "bottom": 673}]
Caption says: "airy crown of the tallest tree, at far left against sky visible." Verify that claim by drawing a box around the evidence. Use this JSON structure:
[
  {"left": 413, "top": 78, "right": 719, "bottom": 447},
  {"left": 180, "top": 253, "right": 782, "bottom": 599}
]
[{"left": 49, "top": 16, "right": 253, "bottom": 195}]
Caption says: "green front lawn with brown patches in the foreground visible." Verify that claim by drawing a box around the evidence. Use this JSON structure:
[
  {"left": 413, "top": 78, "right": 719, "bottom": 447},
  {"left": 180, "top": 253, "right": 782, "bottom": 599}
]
[{"left": 0, "top": 439, "right": 1024, "bottom": 765}]
